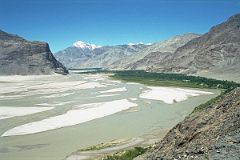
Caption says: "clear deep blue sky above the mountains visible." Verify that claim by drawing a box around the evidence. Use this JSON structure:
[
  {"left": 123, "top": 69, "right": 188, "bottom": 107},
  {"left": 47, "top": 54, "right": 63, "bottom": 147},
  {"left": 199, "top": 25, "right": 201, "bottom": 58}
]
[{"left": 0, "top": 0, "right": 240, "bottom": 52}]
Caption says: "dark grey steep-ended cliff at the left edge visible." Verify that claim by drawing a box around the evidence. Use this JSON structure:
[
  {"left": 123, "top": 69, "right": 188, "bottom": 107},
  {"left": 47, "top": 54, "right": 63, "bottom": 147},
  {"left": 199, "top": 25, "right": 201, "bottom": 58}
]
[{"left": 0, "top": 30, "right": 68, "bottom": 75}]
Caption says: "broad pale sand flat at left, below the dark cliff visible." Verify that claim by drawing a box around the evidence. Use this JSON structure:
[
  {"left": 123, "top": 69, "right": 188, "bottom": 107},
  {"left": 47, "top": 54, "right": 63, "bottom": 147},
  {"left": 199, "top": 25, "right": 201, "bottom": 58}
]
[{"left": 0, "top": 79, "right": 106, "bottom": 99}]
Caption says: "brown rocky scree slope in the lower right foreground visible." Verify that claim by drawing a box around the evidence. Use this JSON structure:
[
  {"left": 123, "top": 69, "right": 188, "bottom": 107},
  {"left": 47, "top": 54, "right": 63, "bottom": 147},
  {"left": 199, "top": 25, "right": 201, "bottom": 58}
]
[{"left": 136, "top": 88, "right": 240, "bottom": 160}]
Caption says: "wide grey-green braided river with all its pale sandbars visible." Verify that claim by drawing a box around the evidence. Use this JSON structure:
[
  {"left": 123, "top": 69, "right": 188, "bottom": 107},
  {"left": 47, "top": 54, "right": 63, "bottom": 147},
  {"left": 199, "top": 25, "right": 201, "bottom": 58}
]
[{"left": 0, "top": 74, "right": 220, "bottom": 160}]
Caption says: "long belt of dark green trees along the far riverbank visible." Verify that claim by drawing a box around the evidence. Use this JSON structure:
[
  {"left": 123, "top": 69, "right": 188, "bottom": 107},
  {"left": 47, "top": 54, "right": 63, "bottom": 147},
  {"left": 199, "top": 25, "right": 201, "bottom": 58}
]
[{"left": 79, "top": 70, "right": 240, "bottom": 90}]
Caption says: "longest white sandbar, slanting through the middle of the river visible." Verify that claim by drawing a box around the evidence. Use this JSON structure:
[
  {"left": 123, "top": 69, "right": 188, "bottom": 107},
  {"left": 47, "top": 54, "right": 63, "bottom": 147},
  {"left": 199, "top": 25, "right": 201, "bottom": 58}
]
[{"left": 2, "top": 99, "right": 137, "bottom": 137}]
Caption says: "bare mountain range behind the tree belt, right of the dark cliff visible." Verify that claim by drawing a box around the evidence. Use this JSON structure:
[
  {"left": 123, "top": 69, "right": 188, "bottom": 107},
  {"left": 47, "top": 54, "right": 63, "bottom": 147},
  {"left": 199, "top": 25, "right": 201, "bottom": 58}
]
[{"left": 55, "top": 14, "right": 240, "bottom": 81}]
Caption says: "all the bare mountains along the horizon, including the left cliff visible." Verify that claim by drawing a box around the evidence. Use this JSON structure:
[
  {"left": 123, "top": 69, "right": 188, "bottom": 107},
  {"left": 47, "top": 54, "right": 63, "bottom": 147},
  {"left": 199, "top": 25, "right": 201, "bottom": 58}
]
[{"left": 0, "top": 14, "right": 240, "bottom": 81}]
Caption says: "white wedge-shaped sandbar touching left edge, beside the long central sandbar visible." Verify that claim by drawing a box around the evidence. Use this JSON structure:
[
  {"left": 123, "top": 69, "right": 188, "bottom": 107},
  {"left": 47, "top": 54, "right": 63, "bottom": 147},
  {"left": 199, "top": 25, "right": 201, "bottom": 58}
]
[{"left": 0, "top": 107, "right": 54, "bottom": 119}]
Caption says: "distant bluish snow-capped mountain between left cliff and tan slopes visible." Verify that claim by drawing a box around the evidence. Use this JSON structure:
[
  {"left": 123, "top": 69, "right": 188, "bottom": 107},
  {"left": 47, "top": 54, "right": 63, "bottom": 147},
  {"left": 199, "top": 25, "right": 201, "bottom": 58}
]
[{"left": 55, "top": 42, "right": 148, "bottom": 68}]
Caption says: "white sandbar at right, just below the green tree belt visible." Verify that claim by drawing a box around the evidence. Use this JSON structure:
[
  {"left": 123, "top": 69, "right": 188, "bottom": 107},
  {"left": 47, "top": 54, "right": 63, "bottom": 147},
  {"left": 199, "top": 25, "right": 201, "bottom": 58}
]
[{"left": 140, "top": 87, "right": 213, "bottom": 104}]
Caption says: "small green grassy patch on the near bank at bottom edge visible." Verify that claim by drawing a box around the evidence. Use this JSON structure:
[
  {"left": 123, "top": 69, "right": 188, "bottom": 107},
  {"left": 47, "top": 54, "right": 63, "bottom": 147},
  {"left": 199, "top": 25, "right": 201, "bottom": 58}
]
[{"left": 102, "top": 147, "right": 147, "bottom": 160}]
